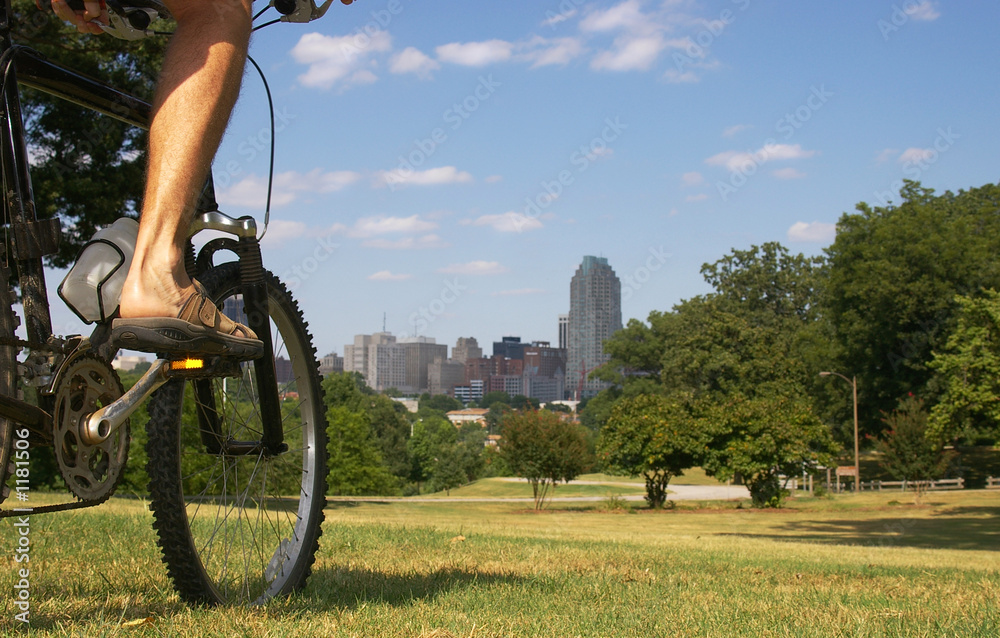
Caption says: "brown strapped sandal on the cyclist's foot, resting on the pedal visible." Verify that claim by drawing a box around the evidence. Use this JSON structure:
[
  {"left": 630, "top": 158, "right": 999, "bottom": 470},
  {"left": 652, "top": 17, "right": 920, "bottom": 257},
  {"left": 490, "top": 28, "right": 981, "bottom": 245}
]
[{"left": 111, "top": 282, "right": 264, "bottom": 359}]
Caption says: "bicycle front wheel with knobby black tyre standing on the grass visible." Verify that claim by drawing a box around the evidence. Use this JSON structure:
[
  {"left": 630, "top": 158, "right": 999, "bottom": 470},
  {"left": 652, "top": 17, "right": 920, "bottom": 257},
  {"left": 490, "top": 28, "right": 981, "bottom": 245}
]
[{"left": 146, "top": 264, "right": 326, "bottom": 604}]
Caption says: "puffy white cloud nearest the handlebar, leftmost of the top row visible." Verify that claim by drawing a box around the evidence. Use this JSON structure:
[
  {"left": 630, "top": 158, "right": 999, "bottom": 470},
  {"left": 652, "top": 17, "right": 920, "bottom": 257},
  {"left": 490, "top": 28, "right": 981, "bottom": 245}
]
[{"left": 292, "top": 30, "right": 392, "bottom": 89}]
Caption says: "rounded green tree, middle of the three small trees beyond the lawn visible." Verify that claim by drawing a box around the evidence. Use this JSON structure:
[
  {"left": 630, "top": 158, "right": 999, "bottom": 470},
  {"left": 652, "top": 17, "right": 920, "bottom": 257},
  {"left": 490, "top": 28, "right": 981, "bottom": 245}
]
[{"left": 598, "top": 395, "right": 705, "bottom": 509}]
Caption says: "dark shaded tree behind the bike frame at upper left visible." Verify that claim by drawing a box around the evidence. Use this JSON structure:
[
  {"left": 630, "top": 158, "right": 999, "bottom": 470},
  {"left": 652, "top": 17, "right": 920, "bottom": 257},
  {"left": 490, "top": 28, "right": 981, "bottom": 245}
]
[{"left": 13, "top": 0, "right": 167, "bottom": 267}]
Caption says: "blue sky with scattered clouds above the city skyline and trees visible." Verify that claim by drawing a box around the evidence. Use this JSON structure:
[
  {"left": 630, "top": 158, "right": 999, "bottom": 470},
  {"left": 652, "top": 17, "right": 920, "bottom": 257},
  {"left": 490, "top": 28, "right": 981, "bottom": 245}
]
[{"left": 51, "top": 0, "right": 1000, "bottom": 354}]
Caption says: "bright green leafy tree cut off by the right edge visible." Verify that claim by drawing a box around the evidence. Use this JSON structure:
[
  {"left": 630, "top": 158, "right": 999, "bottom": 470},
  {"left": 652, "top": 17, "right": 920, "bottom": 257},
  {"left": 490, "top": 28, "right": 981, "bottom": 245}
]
[{"left": 929, "top": 290, "right": 1000, "bottom": 443}]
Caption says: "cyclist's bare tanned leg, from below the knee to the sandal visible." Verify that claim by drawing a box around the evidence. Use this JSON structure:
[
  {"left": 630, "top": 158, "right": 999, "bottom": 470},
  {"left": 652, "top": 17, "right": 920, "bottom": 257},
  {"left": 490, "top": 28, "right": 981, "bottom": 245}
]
[{"left": 120, "top": 0, "right": 251, "bottom": 317}]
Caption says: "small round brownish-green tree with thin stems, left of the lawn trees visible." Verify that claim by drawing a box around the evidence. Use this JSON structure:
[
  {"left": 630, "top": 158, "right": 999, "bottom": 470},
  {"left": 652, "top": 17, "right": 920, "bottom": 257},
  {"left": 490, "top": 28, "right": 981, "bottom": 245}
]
[{"left": 500, "top": 410, "right": 587, "bottom": 509}]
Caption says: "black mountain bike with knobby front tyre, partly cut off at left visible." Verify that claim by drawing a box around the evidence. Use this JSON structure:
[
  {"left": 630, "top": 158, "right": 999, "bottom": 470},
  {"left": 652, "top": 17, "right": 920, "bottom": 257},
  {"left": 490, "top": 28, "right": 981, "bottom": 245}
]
[{"left": 0, "top": 0, "right": 349, "bottom": 605}]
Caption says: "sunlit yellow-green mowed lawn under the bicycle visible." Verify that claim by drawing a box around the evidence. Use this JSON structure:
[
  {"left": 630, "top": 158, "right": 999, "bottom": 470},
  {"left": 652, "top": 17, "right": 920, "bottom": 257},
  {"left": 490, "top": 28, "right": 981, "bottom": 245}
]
[{"left": 0, "top": 490, "right": 1000, "bottom": 638}]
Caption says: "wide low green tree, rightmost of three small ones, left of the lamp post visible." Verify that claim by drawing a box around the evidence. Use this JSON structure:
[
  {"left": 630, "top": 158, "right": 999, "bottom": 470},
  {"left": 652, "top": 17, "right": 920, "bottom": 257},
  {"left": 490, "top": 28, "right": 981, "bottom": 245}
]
[{"left": 701, "top": 395, "right": 837, "bottom": 507}]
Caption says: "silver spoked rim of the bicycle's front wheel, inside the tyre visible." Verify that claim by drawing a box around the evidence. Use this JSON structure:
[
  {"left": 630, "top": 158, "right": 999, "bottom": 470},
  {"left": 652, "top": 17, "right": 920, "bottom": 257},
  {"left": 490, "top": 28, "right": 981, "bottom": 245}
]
[{"left": 178, "top": 284, "right": 322, "bottom": 603}]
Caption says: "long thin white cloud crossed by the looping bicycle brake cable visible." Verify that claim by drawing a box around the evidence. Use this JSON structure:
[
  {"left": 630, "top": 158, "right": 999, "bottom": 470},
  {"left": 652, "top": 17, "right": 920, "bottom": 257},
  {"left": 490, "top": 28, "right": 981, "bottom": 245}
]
[{"left": 217, "top": 168, "right": 361, "bottom": 208}]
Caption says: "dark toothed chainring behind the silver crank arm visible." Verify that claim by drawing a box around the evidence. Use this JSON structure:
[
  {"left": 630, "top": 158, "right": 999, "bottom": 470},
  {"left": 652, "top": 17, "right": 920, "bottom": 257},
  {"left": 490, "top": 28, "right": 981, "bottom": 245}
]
[{"left": 52, "top": 354, "right": 131, "bottom": 500}]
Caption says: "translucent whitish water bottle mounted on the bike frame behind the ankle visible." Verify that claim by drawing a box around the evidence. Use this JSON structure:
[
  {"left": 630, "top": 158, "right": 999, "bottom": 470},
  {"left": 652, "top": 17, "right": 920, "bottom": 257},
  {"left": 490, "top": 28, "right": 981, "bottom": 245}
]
[{"left": 59, "top": 217, "right": 139, "bottom": 323}]
